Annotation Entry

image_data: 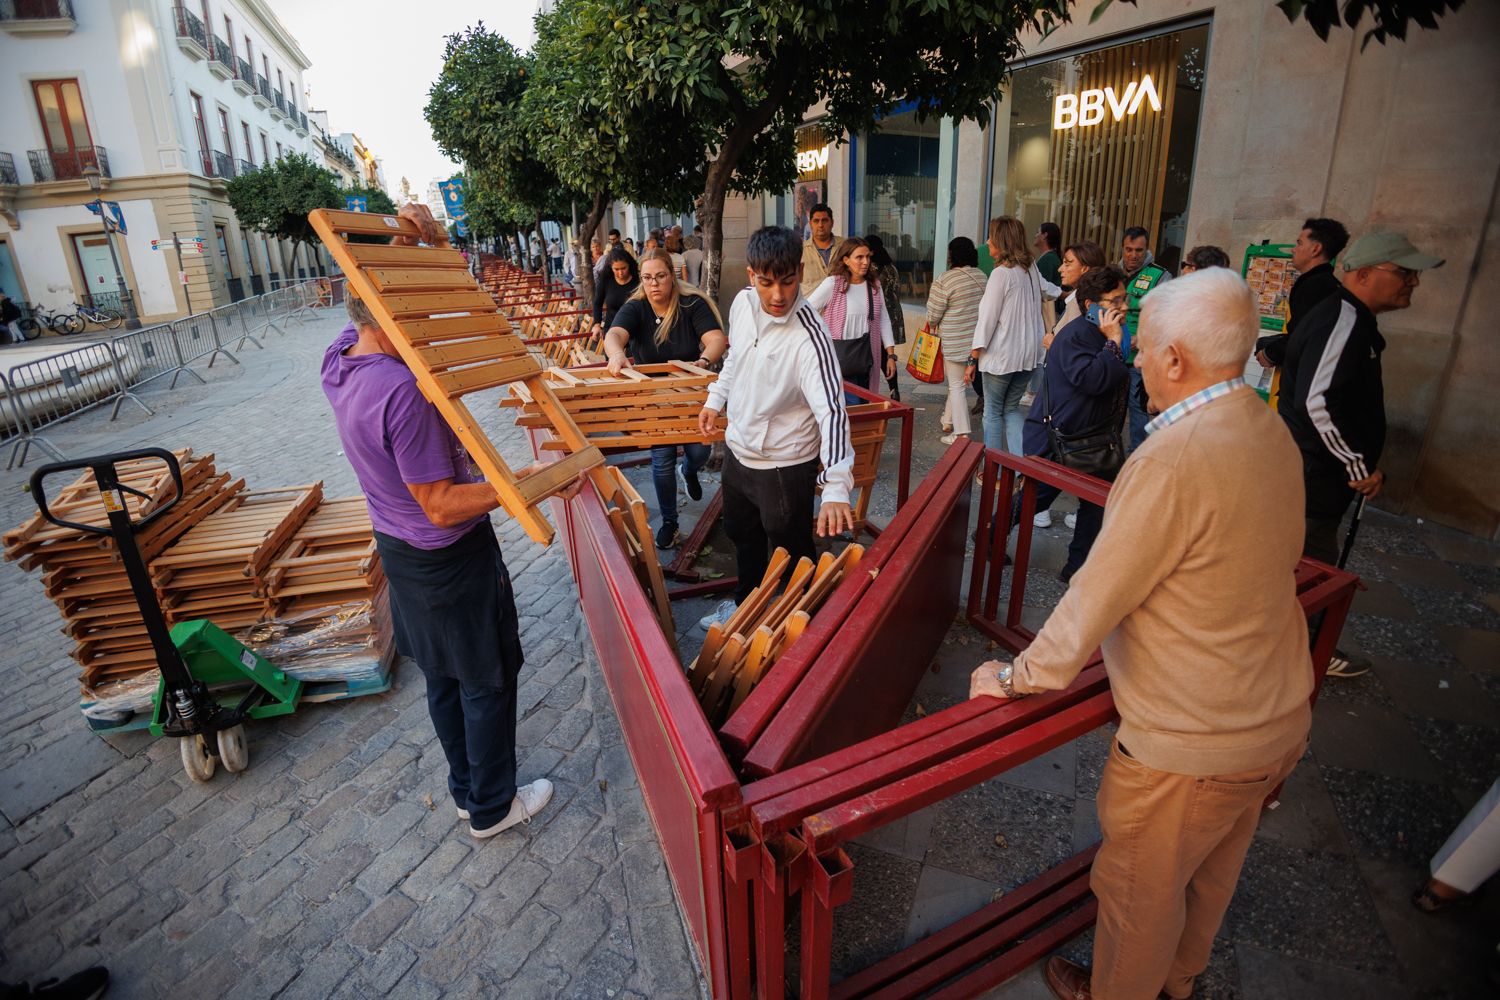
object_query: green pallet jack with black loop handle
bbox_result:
[32,448,303,781]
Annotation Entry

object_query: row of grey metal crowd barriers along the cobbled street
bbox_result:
[0,277,322,469]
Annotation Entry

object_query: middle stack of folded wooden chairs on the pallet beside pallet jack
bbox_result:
[152,483,323,633]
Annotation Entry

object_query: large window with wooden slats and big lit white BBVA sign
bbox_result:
[990,24,1209,270]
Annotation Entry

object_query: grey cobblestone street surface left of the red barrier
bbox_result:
[0,312,701,999]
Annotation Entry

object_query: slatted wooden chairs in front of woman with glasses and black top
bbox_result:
[501,361,726,448]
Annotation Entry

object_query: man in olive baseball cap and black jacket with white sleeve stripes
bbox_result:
[1280,232,1443,678]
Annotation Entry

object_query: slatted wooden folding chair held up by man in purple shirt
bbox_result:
[308,208,605,544]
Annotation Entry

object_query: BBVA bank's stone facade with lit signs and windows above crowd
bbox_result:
[741,0,1500,538]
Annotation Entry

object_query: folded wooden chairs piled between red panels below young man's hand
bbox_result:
[689,544,864,729]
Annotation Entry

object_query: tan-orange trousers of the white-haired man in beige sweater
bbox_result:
[1089,741,1307,1000]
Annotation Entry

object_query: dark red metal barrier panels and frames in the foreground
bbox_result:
[545,425,1358,1000]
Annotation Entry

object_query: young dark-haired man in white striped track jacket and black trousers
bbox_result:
[698,226,854,628]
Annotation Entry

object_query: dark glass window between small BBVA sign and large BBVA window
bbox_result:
[858,109,942,297]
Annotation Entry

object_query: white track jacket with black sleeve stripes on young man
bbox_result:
[708,288,854,504]
